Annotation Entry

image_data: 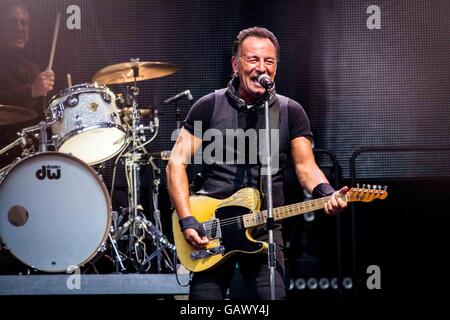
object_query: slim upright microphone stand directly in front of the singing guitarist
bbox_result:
[261,90,276,300]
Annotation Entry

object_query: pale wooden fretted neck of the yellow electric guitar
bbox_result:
[243,195,346,228]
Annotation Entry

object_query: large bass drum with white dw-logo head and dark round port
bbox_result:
[0,152,111,272]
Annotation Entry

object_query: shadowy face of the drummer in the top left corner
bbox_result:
[1,5,30,51]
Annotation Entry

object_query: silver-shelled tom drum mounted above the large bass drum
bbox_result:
[46,83,126,165]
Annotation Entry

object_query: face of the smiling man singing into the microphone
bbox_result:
[231,37,277,103]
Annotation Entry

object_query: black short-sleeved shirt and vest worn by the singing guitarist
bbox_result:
[184,89,312,208]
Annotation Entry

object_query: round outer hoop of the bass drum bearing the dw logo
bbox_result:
[0,151,112,273]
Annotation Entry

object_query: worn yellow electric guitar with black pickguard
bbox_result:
[172,185,388,272]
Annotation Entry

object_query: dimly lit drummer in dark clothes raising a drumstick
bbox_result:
[0,0,55,165]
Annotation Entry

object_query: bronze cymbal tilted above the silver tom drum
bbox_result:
[92,61,179,84]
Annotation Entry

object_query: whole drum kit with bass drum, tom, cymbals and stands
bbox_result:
[0,59,178,273]
